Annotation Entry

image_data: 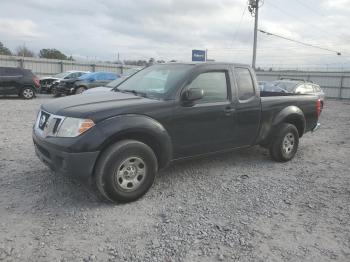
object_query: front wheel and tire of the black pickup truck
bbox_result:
[95,140,158,203]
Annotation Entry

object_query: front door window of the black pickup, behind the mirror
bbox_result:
[188,72,227,103]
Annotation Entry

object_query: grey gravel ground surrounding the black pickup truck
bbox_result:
[0,95,350,261]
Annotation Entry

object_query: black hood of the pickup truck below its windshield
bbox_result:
[41,92,161,123]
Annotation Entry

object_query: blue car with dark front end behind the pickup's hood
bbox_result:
[55,72,120,96]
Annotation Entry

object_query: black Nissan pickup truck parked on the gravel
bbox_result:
[33,63,321,202]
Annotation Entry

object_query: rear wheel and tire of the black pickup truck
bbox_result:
[269,123,299,162]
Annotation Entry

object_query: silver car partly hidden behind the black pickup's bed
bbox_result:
[262,79,325,108]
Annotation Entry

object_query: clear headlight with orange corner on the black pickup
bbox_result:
[57,117,95,137]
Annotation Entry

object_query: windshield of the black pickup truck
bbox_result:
[114,64,191,98]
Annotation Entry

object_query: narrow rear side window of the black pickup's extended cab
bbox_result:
[235,68,255,100]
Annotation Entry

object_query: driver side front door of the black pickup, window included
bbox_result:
[170,67,236,158]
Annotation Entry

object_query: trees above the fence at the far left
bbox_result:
[0,42,74,61]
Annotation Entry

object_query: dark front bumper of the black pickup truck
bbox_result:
[33,131,99,179]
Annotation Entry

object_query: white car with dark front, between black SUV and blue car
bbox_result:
[40,70,90,94]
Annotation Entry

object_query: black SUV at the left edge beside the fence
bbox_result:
[0,67,40,99]
